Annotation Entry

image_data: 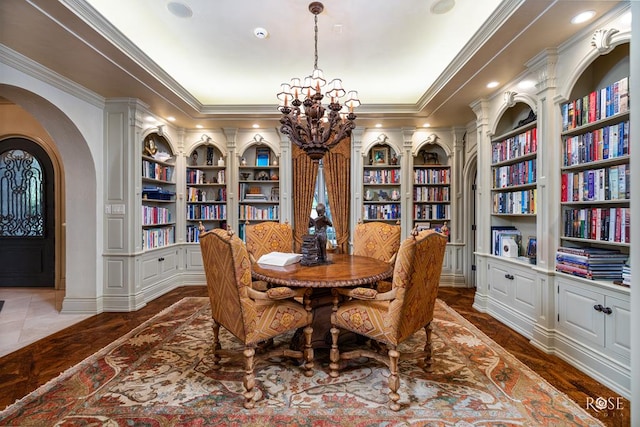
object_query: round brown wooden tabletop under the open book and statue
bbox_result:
[252,254,393,288]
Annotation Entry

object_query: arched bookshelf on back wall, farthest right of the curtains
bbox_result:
[413,145,451,229]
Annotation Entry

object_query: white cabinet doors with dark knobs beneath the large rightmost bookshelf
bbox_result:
[557,279,631,363]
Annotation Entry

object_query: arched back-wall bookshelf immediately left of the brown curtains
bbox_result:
[238,146,280,238]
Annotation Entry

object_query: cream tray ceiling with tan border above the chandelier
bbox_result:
[0,0,620,129]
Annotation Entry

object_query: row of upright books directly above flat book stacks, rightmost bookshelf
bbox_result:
[563,207,631,243]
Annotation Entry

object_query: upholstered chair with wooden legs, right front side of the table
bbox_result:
[329,229,447,411]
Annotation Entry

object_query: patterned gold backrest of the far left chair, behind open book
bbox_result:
[244,221,293,261]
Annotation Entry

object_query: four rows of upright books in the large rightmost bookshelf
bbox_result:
[560,76,631,264]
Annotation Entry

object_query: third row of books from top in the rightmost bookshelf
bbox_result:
[560,164,631,202]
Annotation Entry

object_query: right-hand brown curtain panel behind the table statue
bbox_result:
[323,138,351,253]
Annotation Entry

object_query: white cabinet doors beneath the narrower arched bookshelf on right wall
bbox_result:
[487,257,540,338]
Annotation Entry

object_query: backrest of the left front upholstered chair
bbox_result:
[199,229,254,342]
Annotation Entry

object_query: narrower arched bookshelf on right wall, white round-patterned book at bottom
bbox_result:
[491,102,539,262]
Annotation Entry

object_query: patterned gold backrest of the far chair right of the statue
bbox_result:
[353,221,401,262]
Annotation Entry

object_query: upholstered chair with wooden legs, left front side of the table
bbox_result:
[199,225,313,409]
